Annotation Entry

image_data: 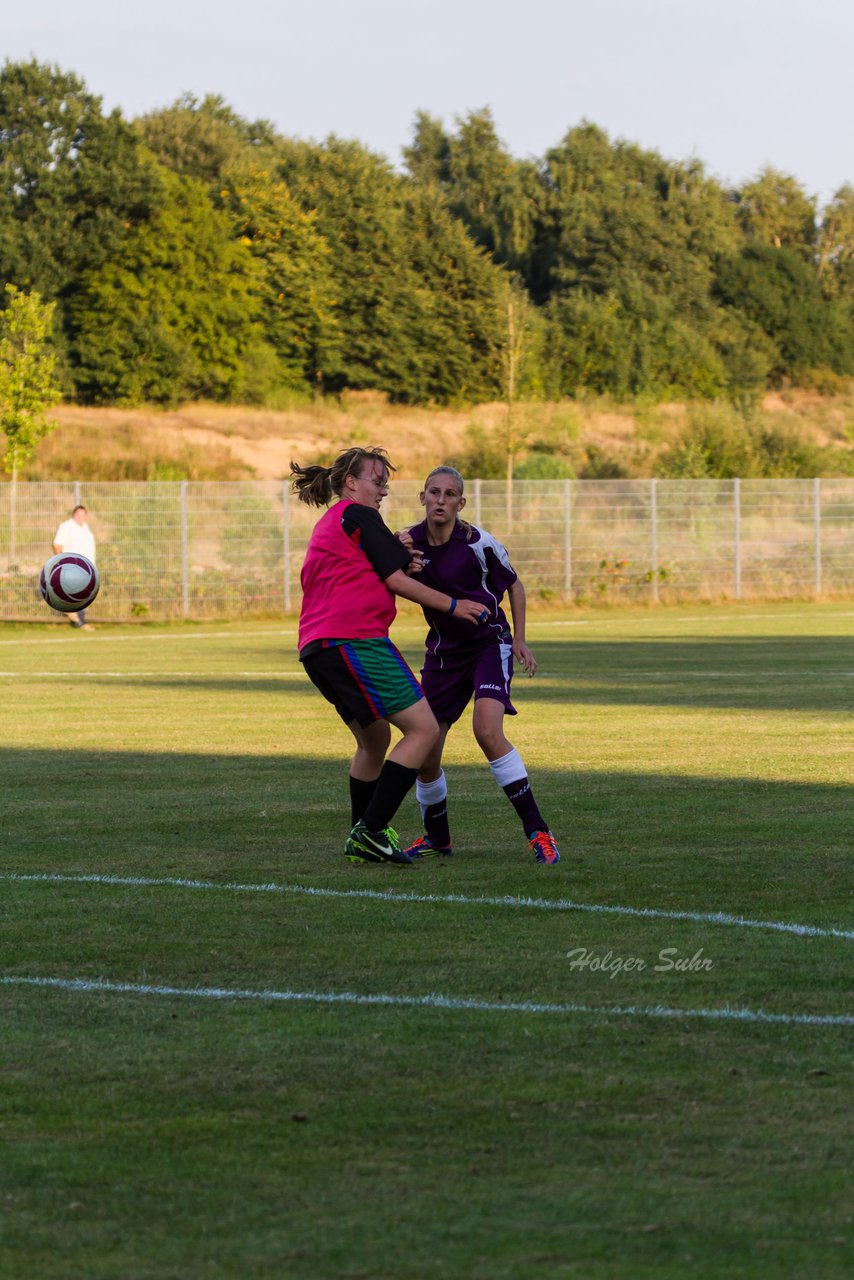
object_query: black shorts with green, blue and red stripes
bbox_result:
[300,637,424,728]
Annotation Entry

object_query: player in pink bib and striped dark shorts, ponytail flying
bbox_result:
[291,448,484,863]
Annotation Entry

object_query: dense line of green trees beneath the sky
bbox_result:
[0,60,854,404]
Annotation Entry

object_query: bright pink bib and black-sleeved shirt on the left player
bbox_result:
[298,499,410,657]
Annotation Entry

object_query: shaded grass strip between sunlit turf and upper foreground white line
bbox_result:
[0,750,854,924]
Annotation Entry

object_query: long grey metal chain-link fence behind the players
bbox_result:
[0,479,854,620]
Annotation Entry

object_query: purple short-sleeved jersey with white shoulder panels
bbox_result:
[410,521,516,654]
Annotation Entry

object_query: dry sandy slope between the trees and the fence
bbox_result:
[22,392,854,480]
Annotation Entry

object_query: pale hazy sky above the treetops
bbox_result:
[6,0,854,204]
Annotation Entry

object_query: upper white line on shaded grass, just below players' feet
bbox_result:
[0,872,854,941]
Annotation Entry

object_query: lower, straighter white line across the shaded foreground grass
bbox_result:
[0,975,854,1027]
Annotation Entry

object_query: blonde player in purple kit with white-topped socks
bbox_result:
[398,467,561,865]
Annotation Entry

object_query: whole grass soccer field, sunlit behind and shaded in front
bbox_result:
[0,603,854,1280]
